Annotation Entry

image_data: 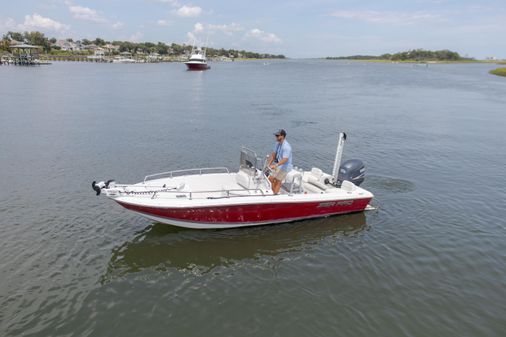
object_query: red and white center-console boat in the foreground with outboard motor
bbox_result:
[92,133,373,228]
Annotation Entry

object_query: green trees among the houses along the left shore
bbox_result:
[0,31,285,59]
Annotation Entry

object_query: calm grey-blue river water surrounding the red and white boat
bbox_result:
[0,60,506,337]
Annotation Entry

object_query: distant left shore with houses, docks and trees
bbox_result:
[0,31,285,64]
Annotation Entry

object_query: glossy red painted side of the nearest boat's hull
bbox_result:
[118,198,371,224]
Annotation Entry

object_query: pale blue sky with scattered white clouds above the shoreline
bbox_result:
[0,0,506,59]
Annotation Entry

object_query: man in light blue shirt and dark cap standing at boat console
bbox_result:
[268,129,293,194]
